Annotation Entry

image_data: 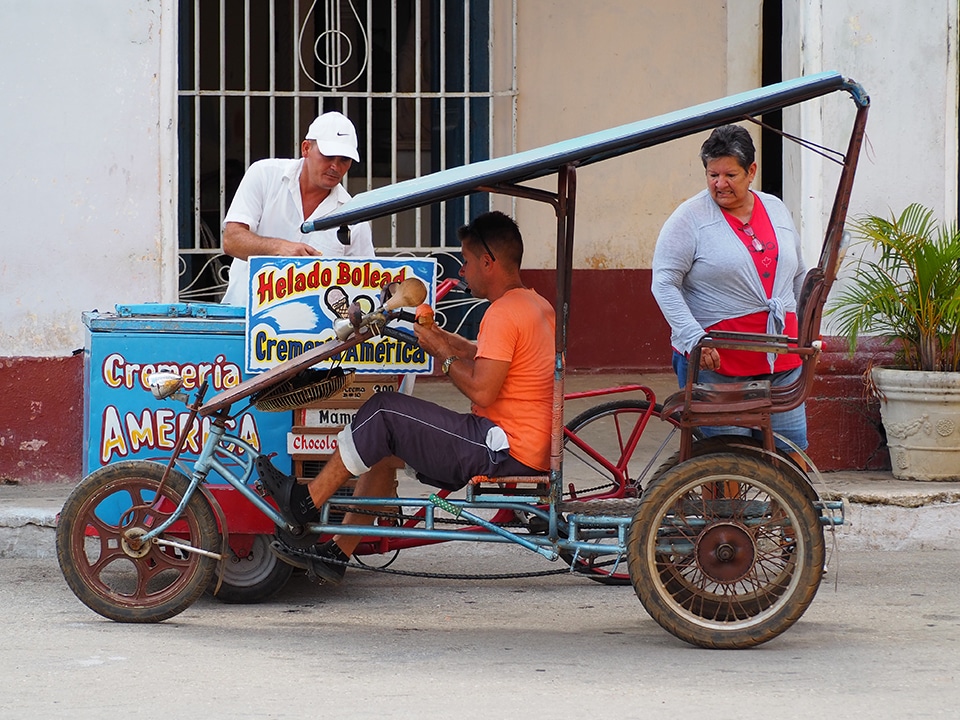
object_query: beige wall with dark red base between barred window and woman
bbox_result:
[506,0,761,371]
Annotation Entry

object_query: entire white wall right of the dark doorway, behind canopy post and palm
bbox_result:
[783,0,957,292]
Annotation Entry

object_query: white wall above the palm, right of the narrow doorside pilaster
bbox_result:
[823,0,957,218]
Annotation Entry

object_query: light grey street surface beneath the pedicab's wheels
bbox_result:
[7,543,960,720]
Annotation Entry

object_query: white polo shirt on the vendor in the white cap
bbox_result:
[222,158,374,305]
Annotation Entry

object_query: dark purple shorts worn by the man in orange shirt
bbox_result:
[339,392,543,490]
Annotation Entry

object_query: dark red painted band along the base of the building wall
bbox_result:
[0,270,890,483]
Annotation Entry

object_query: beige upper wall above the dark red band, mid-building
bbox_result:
[517,0,760,270]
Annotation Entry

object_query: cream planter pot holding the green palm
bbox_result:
[872,368,960,481]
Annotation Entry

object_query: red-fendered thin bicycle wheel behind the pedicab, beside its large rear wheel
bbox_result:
[560,400,679,585]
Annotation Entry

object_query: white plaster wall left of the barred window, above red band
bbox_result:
[0,0,176,357]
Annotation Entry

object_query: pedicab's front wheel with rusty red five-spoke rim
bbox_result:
[57,460,221,623]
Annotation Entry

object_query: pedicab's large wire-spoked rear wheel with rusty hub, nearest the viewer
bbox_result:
[627,453,824,649]
